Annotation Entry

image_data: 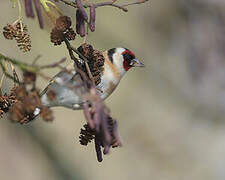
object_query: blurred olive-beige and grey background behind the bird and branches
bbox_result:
[0,0,225,180]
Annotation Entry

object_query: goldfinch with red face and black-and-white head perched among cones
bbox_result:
[35,47,144,114]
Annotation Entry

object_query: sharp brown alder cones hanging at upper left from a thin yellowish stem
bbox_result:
[3,21,31,52]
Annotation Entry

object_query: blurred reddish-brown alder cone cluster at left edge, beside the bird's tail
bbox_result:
[0,72,53,124]
